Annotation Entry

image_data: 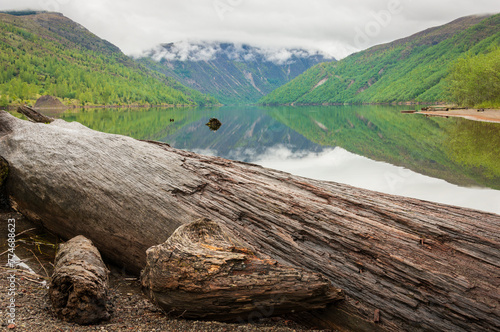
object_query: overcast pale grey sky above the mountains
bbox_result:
[0,0,500,58]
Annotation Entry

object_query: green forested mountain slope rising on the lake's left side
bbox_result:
[0,11,217,106]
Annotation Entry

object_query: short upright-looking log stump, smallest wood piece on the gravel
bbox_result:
[49,236,110,325]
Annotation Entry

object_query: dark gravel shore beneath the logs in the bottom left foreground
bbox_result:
[0,211,332,332]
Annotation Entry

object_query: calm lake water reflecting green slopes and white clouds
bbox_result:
[28,106,500,214]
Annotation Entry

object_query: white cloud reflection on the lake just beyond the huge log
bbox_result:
[196,145,500,214]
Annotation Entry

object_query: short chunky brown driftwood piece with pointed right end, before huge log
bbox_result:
[141,218,344,321]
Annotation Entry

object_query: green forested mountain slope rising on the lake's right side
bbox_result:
[260,15,500,104]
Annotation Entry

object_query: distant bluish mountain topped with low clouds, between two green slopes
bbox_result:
[137,42,332,104]
